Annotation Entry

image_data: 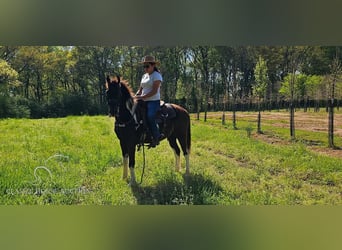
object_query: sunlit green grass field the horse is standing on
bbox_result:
[0,113,342,205]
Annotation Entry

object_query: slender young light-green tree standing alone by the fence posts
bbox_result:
[253,56,269,134]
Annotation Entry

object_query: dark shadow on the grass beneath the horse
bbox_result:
[132,174,223,205]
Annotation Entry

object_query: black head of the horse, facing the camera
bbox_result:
[106,76,121,116]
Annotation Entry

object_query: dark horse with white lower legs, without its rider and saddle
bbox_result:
[105,75,191,185]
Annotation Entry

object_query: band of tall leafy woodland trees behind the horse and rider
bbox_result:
[0,46,342,122]
